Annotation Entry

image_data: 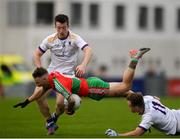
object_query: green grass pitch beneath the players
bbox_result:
[0,98,180,138]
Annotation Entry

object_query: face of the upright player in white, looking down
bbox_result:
[55,22,69,39]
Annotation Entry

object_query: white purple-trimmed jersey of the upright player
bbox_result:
[39,31,88,75]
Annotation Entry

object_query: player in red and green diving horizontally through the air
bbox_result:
[14,48,150,135]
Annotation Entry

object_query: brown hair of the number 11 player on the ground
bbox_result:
[126,93,144,107]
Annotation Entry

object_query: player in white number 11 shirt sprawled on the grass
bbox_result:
[105,93,180,137]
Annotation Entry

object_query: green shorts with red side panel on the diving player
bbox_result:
[86,77,109,100]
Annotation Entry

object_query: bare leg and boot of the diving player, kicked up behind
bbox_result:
[107,48,150,97]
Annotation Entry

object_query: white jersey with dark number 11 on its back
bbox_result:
[139,96,180,135]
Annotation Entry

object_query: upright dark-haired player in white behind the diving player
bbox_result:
[29,14,92,134]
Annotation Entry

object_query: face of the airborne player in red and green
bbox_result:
[34,74,50,88]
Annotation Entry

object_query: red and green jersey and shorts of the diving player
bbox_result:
[49,71,109,100]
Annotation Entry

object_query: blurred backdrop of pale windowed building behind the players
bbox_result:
[0,0,180,97]
